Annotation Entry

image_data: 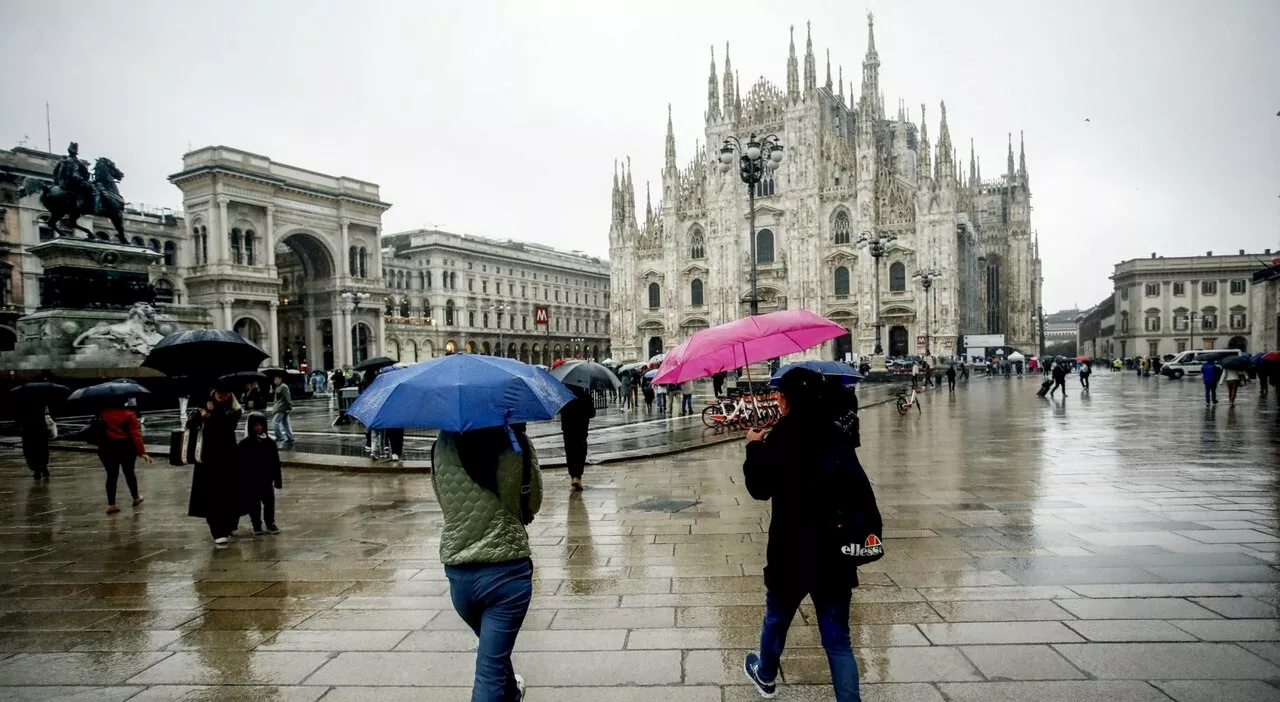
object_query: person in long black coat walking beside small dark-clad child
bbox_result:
[187,389,248,547]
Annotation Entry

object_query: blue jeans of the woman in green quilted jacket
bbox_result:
[444,559,534,702]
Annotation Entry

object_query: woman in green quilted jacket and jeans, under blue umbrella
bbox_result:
[431,425,543,702]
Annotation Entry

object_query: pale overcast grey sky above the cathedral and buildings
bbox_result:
[0,0,1280,309]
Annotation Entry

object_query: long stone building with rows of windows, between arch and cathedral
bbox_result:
[383,229,609,365]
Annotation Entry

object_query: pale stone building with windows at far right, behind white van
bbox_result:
[1111,250,1276,357]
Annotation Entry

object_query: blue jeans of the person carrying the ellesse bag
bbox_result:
[760,589,863,702]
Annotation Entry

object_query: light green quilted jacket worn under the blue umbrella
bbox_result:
[431,432,543,565]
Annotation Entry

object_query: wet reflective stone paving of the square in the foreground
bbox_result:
[0,374,1280,702]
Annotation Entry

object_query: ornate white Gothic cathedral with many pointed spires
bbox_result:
[609,18,1041,359]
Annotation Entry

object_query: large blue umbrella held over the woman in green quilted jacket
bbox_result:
[347,354,573,432]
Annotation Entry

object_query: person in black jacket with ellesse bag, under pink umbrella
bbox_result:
[742,369,881,702]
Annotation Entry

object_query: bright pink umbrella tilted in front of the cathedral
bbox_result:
[653,310,849,384]
